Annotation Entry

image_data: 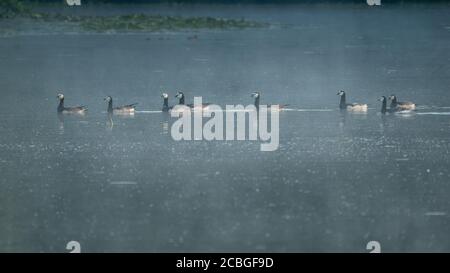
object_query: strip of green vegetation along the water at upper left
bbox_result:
[0,0,267,32]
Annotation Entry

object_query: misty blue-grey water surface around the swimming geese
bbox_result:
[0,5,450,252]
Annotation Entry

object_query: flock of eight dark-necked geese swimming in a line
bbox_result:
[57,91,416,115]
